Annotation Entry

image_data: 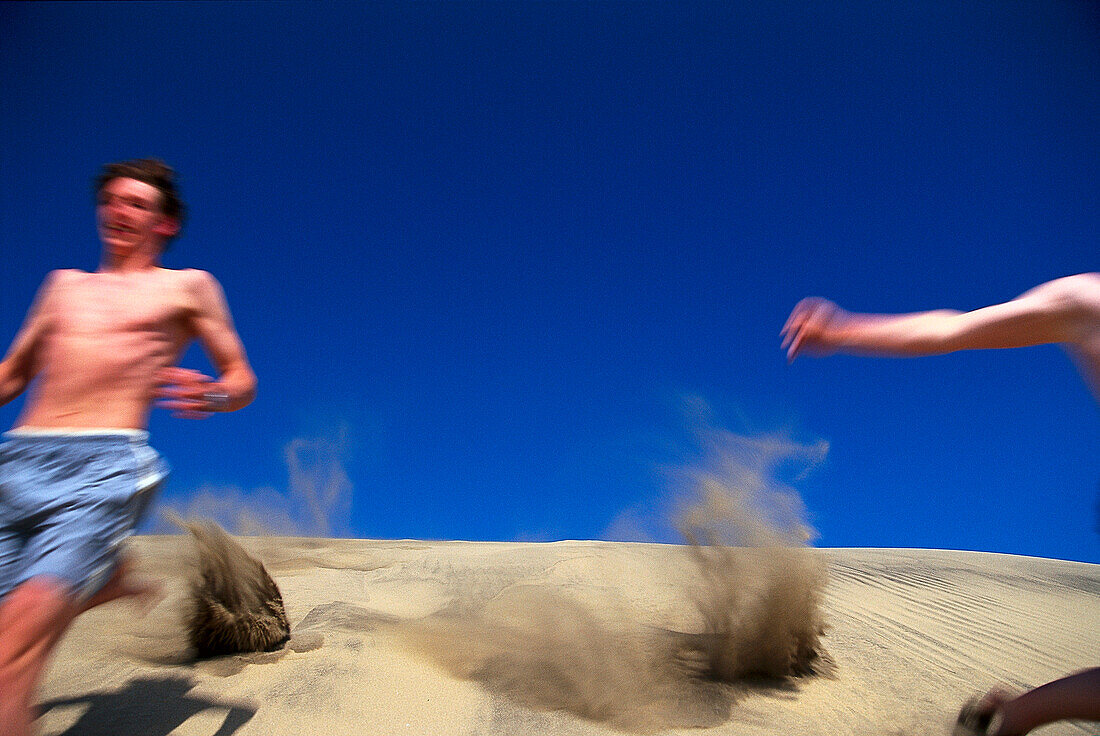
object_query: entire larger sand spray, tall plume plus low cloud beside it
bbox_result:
[403,418,826,733]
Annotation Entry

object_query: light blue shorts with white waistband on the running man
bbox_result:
[0,428,168,600]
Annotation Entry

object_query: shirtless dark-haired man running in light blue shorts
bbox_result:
[0,160,256,736]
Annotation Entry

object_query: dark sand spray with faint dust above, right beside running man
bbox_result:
[110,428,352,673]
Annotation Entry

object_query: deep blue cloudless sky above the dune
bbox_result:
[0,0,1100,562]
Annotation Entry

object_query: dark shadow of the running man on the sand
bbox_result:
[41,677,256,736]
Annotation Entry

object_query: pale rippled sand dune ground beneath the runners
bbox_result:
[39,536,1100,736]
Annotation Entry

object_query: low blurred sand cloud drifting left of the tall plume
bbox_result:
[398,586,724,732]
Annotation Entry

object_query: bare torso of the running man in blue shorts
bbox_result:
[17,267,205,428]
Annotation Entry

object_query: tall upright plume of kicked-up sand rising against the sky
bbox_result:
[678,430,827,682]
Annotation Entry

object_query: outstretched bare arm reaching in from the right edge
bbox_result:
[782,274,1100,361]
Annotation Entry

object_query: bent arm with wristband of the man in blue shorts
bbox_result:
[157,271,256,418]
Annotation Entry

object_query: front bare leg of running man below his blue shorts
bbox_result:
[0,578,80,736]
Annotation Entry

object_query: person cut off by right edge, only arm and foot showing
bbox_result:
[782,273,1100,736]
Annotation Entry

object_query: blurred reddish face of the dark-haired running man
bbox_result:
[96,177,177,255]
